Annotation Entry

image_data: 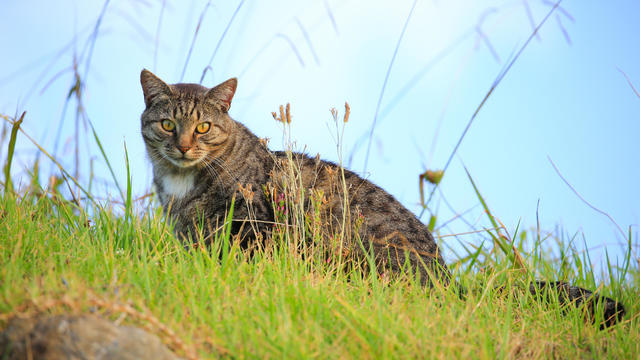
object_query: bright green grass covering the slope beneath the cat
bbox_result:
[0,176,640,359]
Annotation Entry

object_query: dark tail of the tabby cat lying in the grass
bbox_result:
[529,281,625,329]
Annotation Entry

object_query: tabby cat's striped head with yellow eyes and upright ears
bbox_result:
[140,69,238,172]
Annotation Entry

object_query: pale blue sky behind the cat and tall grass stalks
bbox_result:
[0,0,640,274]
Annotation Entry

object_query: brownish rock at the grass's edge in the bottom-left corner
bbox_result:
[0,315,178,360]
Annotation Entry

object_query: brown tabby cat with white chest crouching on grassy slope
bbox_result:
[140,69,625,326]
